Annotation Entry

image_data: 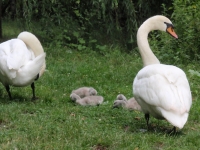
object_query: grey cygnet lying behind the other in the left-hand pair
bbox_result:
[72,87,97,98]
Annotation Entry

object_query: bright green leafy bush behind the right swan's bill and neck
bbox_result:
[150,0,200,64]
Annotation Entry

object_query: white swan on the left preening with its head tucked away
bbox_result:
[0,32,46,100]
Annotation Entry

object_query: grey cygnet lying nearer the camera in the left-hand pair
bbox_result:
[70,93,104,106]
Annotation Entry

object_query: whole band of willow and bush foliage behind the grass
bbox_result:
[0,0,200,63]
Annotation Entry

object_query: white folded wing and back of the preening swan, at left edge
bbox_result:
[0,39,34,79]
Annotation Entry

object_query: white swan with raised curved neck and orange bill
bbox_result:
[133,15,192,132]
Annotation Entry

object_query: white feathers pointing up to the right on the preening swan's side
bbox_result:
[18,53,46,82]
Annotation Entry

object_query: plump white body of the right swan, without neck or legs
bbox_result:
[133,64,192,128]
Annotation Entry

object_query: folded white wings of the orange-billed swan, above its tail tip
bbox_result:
[133,65,192,114]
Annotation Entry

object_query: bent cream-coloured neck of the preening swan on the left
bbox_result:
[17,31,44,57]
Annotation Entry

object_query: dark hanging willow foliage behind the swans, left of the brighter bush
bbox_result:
[3,0,171,53]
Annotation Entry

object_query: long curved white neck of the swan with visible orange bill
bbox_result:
[137,20,160,66]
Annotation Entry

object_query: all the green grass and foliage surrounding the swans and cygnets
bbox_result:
[0,0,200,150]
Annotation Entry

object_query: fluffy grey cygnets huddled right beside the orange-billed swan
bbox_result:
[113,94,141,111]
